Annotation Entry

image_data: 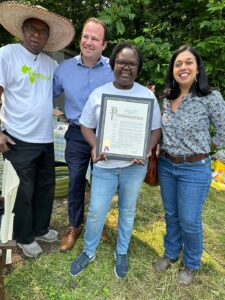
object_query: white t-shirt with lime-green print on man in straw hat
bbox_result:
[0,44,57,143]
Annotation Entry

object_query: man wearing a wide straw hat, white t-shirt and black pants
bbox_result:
[0,2,74,257]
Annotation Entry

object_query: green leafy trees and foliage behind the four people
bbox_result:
[0,0,225,95]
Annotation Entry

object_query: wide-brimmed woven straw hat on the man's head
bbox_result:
[0,1,75,51]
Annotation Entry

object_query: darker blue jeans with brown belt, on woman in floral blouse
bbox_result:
[158,156,212,270]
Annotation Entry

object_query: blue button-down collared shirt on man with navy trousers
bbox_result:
[53,55,114,124]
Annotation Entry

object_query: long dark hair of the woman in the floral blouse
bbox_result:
[163,45,212,100]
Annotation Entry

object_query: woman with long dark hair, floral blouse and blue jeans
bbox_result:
[153,45,225,285]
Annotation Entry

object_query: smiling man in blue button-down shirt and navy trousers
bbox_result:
[54,18,114,251]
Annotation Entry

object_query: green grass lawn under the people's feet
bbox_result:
[5,184,225,300]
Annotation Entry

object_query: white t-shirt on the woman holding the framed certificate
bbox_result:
[80,82,161,168]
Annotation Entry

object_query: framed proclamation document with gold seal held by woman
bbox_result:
[97,94,154,160]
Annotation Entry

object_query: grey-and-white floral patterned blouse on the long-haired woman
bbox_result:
[161,91,225,155]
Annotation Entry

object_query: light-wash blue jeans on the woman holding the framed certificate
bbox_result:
[84,165,147,257]
